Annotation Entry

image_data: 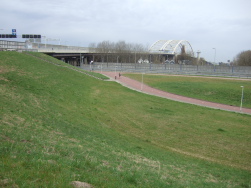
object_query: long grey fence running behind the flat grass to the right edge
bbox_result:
[81,62,251,78]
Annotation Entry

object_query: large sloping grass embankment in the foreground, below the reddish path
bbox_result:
[0,52,251,188]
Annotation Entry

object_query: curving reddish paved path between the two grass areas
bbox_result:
[102,72,251,115]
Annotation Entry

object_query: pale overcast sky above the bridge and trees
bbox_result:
[0,0,251,62]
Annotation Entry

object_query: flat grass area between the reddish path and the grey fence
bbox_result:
[124,74,251,108]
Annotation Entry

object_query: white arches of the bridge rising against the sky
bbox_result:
[149,40,194,56]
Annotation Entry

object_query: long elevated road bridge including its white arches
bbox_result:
[0,40,193,66]
